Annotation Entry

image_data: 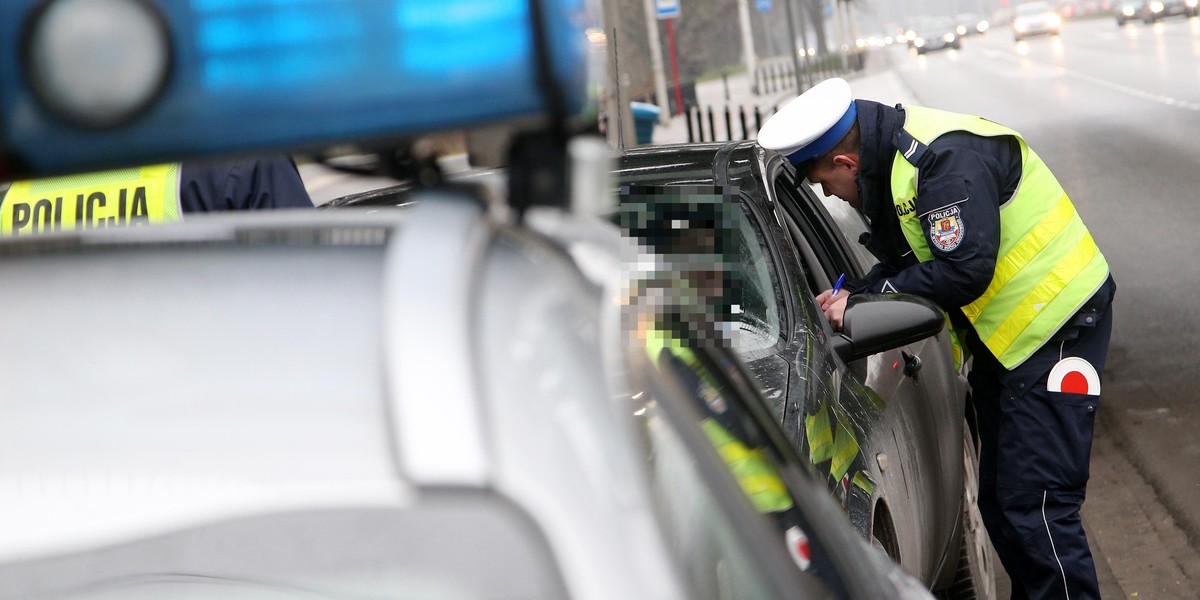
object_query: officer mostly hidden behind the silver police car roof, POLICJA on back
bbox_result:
[0,155,312,236]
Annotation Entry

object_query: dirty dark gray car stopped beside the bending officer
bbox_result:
[618,143,994,598]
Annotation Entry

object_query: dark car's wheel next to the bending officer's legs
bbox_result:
[946,424,996,600]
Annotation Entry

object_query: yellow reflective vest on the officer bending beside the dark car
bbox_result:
[892,107,1109,370]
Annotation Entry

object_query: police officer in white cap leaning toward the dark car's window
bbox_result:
[758,79,1116,600]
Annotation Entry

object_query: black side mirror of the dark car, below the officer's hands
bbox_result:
[832,294,946,362]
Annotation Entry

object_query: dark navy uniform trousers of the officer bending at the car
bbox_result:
[968,278,1115,600]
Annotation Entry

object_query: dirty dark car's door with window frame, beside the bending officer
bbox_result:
[762,150,964,583]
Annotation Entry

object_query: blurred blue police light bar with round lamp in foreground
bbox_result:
[0,0,589,181]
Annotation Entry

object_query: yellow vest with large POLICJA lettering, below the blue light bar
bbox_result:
[0,163,182,236]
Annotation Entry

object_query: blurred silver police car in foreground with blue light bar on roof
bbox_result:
[0,0,928,599]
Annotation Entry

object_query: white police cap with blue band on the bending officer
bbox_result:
[758,77,858,164]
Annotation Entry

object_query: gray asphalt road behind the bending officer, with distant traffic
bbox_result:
[888,18,1200,599]
